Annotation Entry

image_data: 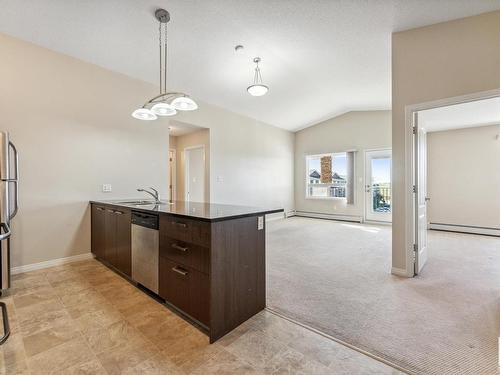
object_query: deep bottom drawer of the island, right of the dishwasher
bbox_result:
[160,257,210,326]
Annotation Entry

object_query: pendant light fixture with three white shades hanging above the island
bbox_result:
[132,9,198,121]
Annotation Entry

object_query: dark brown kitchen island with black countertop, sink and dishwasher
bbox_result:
[90,200,283,342]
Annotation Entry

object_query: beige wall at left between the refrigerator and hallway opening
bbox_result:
[0,34,168,266]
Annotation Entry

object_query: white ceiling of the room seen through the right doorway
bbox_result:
[418,97,500,132]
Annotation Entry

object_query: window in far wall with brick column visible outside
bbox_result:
[306,152,353,203]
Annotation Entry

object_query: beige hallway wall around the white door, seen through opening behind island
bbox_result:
[170,129,210,203]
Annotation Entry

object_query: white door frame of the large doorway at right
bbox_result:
[404,89,500,277]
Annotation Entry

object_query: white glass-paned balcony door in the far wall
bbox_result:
[365,149,392,222]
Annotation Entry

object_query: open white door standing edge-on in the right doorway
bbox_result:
[413,113,428,274]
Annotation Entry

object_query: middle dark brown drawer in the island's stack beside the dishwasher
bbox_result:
[160,236,210,273]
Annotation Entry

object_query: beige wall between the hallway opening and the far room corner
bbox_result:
[176,105,295,211]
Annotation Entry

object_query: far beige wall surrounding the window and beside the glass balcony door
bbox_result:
[295,111,391,217]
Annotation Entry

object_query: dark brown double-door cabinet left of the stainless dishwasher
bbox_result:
[91,205,132,276]
